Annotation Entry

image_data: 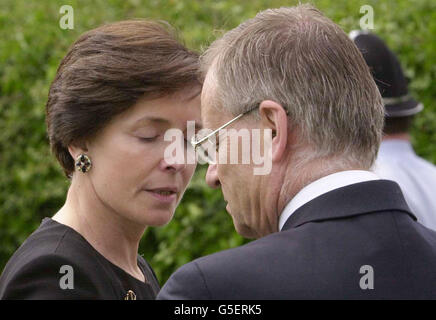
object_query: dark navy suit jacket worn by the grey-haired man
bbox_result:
[158,180,436,299]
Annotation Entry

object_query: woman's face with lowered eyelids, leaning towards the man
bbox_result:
[83,90,200,226]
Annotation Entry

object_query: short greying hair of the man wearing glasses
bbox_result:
[201,5,384,168]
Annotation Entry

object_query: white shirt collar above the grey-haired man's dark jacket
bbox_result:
[279,170,380,230]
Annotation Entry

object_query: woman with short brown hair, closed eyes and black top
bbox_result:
[0,20,201,299]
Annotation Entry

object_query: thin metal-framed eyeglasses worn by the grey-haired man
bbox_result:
[191,104,260,164]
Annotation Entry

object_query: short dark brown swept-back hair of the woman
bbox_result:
[46,20,201,177]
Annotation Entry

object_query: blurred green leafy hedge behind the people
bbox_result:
[0,0,436,284]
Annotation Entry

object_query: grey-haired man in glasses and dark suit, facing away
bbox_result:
[158,5,436,300]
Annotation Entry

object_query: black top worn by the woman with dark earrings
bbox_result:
[0,218,159,300]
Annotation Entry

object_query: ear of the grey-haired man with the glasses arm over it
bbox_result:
[259,100,288,162]
